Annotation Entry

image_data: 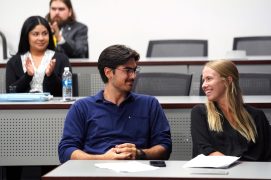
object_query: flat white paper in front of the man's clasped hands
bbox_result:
[95,161,159,172]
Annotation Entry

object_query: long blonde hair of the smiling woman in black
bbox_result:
[205,60,257,142]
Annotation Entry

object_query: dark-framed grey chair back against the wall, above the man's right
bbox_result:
[147,40,208,57]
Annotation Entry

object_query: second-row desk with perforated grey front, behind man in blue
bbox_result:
[0,96,271,166]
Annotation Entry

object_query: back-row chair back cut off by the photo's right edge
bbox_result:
[233,36,271,56]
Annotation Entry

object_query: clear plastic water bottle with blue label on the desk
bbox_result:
[62,67,72,101]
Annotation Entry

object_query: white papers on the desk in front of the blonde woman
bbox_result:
[183,154,240,168]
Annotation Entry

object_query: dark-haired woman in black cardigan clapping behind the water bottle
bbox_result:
[6,16,71,96]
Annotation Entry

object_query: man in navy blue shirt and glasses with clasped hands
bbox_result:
[58,45,172,163]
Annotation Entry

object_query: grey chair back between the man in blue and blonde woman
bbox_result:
[133,73,192,96]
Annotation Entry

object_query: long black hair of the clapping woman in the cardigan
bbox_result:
[18,16,55,54]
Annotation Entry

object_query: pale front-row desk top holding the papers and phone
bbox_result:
[42,160,271,180]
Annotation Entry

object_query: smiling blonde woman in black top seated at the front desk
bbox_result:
[191,60,271,161]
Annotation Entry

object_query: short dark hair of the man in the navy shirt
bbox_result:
[98,45,140,83]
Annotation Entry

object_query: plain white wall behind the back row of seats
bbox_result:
[0,0,271,60]
